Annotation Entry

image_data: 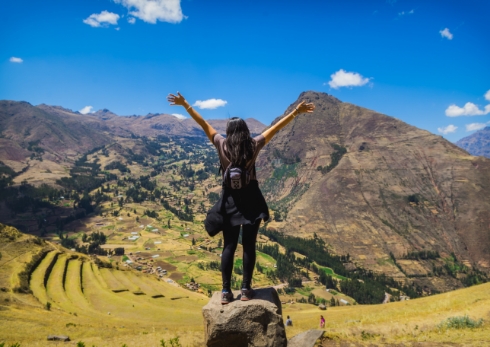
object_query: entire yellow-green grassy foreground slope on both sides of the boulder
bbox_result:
[0,225,490,347]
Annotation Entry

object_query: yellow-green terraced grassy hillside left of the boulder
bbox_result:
[0,224,207,347]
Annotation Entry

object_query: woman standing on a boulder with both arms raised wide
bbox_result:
[167,92,315,305]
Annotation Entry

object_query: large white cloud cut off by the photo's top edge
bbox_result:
[114,0,184,24]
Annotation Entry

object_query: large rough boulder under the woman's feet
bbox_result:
[202,288,287,347]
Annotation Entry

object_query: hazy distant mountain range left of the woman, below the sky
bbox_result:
[0,100,265,182]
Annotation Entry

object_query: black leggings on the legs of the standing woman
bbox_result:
[221,219,262,290]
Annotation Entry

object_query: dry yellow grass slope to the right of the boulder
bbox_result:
[283,283,490,346]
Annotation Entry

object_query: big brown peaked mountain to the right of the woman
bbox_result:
[259,92,490,290]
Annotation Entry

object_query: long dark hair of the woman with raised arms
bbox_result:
[225,117,255,166]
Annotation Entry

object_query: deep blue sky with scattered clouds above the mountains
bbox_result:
[0,0,490,141]
